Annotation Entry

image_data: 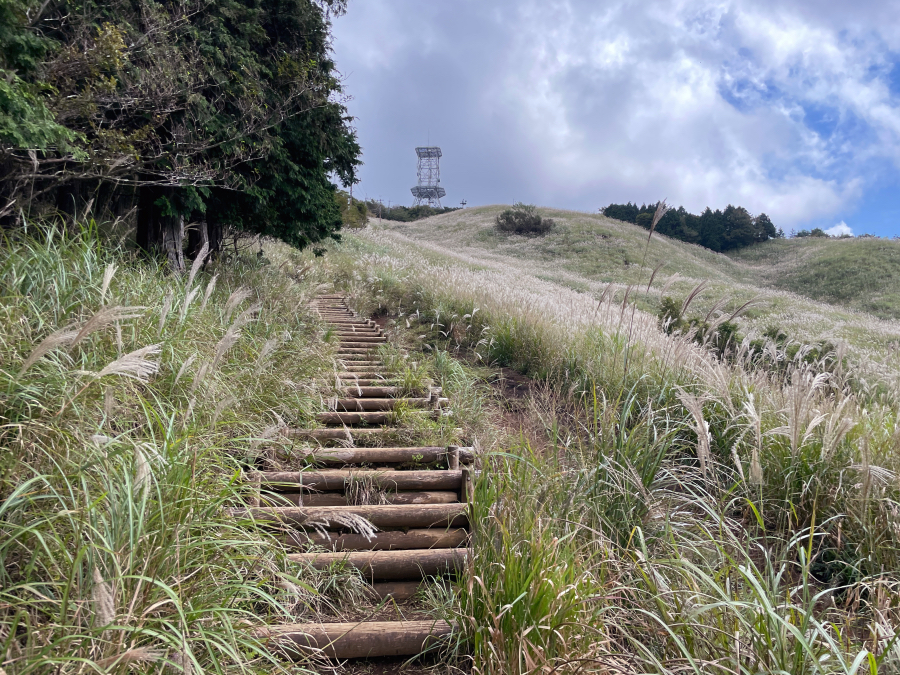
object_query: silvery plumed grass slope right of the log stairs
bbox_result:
[329,208,900,673]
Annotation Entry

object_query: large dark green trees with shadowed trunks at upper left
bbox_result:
[0,0,361,269]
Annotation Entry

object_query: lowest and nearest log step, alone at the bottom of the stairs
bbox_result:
[255,620,453,659]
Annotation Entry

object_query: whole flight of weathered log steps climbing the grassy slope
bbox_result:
[233,295,473,659]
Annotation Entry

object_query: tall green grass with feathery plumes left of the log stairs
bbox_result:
[0,223,338,673]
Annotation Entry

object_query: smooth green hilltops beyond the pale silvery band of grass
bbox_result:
[384,206,900,319]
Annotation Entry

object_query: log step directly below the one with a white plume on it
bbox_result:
[279,527,469,551]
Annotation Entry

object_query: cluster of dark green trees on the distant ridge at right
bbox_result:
[600,202,784,252]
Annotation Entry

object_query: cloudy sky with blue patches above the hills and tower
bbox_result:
[333,0,900,236]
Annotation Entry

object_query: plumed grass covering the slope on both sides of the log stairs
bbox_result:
[0,209,900,675]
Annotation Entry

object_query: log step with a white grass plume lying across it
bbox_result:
[228,504,469,530]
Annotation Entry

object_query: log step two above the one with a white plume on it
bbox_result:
[256,470,462,492]
